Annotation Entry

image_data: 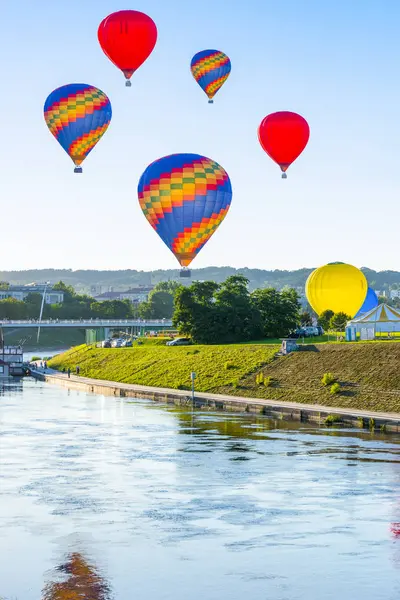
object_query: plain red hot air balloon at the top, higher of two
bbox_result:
[97,10,157,87]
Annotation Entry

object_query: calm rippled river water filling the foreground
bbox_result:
[0,379,400,600]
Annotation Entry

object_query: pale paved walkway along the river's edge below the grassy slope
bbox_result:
[28,367,400,426]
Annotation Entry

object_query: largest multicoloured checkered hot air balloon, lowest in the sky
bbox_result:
[138,154,232,277]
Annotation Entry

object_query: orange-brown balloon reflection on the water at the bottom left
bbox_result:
[43,552,111,600]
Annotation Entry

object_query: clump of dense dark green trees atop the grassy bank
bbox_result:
[173,275,300,344]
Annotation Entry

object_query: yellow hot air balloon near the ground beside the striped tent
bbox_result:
[306,263,368,317]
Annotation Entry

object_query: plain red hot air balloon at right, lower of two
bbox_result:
[258,111,310,179]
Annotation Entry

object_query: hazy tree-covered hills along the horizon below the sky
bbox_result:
[0,267,400,293]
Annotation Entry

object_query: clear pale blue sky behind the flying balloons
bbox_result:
[0,0,400,270]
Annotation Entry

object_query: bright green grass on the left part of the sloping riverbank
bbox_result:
[49,343,279,393]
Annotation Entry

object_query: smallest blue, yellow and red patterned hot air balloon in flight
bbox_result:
[190,50,231,104]
